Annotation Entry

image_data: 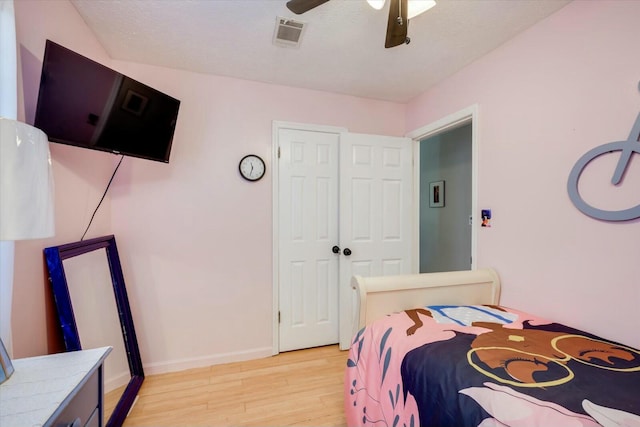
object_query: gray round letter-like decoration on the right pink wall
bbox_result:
[567,114,640,221]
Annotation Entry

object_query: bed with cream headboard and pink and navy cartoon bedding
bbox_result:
[344,269,640,427]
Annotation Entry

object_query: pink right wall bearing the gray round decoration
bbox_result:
[407,1,640,347]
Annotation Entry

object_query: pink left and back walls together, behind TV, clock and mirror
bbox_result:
[14,0,405,366]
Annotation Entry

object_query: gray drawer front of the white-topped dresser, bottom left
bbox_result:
[47,369,102,427]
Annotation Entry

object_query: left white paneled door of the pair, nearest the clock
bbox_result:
[278,129,340,351]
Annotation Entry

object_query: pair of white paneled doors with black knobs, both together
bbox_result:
[276,128,414,351]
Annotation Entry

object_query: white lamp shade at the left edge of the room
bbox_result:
[0,117,55,240]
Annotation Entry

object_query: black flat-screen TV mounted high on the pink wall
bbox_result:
[34,40,180,163]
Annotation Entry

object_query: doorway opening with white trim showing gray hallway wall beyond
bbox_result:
[407,105,479,272]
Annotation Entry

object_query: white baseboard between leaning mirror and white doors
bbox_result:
[143,347,273,375]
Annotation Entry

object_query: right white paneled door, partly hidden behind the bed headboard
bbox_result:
[340,133,414,350]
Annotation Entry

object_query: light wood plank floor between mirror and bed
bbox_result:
[117,345,347,427]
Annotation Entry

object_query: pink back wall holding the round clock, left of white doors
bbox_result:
[105,63,404,372]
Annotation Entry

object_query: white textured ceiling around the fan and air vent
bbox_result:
[71,0,568,102]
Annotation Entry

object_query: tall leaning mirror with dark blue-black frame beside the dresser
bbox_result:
[44,235,144,427]
